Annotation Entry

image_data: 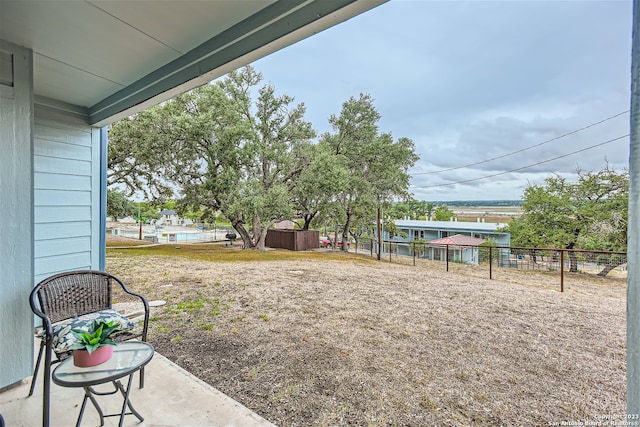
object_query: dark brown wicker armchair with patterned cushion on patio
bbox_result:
[29,270,149,426]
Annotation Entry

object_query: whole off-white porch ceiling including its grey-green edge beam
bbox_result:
[0,0,386,126]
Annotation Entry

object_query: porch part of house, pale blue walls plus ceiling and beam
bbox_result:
[0,0,384,398]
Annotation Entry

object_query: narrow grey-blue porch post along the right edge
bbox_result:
[627,0,640,415]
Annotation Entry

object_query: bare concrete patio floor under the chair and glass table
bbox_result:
[0,353,273,427]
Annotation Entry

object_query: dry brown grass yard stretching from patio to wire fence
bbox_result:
[107,250,626,426]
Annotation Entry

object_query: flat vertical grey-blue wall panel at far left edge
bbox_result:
[0,40,33,389]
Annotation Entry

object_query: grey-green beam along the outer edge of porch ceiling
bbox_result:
[89,0,387,126]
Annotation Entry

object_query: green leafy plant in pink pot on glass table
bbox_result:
[69,319,120,368]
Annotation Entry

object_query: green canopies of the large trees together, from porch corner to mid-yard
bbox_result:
[108,67,418,248]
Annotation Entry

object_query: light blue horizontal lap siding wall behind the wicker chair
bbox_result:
[34,108,100,282]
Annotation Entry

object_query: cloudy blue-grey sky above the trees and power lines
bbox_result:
[253,0,632,201]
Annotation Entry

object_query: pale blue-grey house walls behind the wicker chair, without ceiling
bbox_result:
[0,40,106,389]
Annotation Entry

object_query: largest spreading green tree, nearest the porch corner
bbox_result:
[109,67,315,248]
